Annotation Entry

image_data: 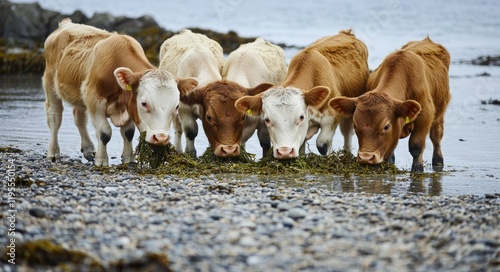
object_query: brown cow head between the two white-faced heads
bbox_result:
[181,80,273,158]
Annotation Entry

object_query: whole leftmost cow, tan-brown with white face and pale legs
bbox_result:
[42,19,198,166]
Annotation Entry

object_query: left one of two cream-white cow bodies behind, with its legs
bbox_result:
[159,29,224,157]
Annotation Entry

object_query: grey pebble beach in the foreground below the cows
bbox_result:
[0,152,500,271]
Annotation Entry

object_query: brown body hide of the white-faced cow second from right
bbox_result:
[281,30,369,112]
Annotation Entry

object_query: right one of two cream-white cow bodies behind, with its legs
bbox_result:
[222,38,286,156]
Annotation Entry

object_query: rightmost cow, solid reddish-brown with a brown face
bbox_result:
[328,37,451,172]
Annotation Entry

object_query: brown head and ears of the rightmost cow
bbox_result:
[328,92,421,164]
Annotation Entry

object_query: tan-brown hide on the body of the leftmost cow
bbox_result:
[44,21,155,126]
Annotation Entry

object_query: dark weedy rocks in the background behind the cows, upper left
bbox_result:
[0,0,287,75]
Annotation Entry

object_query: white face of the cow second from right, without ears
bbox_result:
[262,87,309,158]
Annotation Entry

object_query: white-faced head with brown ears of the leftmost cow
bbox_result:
[114,67,198,145]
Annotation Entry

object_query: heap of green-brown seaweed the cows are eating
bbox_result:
[136,135,406,177]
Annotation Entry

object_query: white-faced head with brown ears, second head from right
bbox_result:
[236,86,330,159]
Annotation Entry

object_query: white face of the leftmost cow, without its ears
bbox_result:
[136,70,180,145]
